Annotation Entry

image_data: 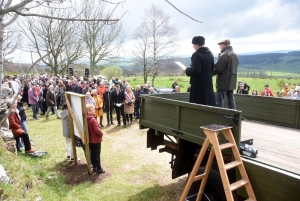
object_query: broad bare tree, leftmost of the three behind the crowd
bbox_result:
[23,8,84,74]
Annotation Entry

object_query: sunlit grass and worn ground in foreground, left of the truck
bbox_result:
[0,111,185,201]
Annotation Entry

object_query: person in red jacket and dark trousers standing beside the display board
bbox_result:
[86,104,105,174]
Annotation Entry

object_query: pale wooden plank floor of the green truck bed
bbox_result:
[241,120,300,174]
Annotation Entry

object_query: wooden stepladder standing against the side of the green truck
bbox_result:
[180,124,256,201]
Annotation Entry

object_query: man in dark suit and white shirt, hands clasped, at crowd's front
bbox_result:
[112,84,126,128]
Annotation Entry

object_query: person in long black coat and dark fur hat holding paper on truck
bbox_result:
[183,36,215,106]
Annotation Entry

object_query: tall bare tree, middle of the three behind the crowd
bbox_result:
[82,0,124,75]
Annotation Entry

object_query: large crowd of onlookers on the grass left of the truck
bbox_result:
[4,75,166,168]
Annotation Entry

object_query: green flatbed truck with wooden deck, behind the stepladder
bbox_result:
[140,93,300,201]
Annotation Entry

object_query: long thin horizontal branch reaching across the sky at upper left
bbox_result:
[12,10,120,22]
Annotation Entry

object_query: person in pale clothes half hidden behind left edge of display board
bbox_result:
[60,103,74,161]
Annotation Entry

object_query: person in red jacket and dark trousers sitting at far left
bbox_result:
[7,102,35,153]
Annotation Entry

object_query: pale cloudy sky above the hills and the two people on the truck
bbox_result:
[114,0,300,55]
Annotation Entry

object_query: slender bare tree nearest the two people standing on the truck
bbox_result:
[131,5,177,86]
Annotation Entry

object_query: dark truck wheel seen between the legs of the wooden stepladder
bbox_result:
[187,164,226,201]
